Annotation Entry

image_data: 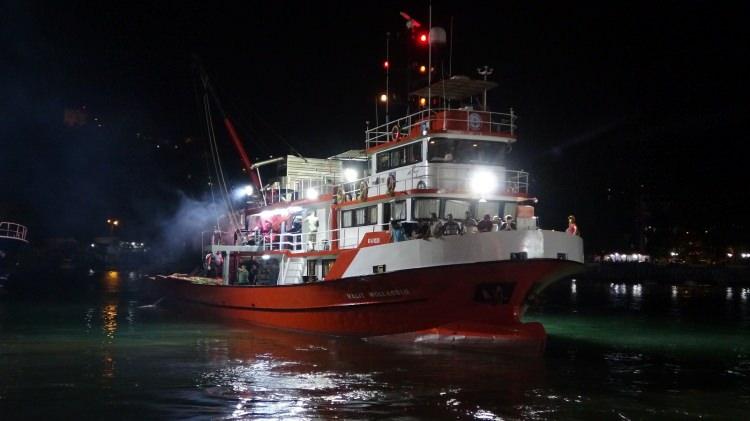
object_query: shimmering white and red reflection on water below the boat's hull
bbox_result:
[191,325,544,419]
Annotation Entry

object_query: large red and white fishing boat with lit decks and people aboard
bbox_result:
[154,20,583,350]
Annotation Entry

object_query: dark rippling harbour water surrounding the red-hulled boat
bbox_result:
[0,272,750,420]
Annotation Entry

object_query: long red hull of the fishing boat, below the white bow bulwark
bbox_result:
[156,260,581,338]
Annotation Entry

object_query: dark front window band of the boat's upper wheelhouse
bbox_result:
[427,138,505,165]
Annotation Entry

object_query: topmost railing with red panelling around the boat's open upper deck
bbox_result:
[365,108,517,149]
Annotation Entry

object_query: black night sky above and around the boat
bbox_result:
[0,1,750,253]
